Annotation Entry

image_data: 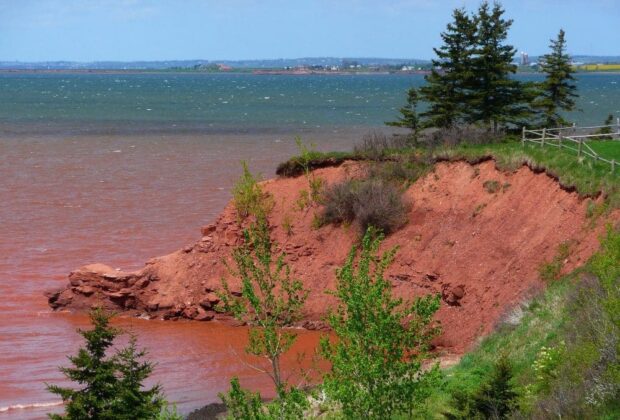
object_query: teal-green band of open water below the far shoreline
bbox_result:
[0,73,620,133]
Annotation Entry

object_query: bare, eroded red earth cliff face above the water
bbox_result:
[48,161,619,353]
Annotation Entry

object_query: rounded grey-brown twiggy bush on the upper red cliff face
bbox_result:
[321,178,409,235]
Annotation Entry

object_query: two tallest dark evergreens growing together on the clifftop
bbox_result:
[420,1,536,133]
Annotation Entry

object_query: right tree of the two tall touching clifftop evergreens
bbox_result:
[467,1,529,132]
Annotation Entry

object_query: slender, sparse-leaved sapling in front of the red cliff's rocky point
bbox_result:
[219,218,308,413]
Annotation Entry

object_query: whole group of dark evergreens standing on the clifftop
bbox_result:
[387,1,577,134]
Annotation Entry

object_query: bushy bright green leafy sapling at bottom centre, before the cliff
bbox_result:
[321,228,440,418]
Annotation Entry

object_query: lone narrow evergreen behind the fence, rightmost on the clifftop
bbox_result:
[537,30,578,127]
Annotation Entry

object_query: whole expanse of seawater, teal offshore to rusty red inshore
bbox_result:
[0,73,620,419]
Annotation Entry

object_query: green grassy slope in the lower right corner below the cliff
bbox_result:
[424,226,620,418]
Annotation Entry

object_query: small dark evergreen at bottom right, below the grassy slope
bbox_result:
[446,354,517,419]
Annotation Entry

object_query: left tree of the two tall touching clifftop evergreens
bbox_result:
[420,9,476,128]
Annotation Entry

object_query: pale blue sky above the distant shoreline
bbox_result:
[0,0,620,61]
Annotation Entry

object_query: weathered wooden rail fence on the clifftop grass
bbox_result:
[521,118,620,172]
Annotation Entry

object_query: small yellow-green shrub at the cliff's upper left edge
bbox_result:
[232,162,273,221]
